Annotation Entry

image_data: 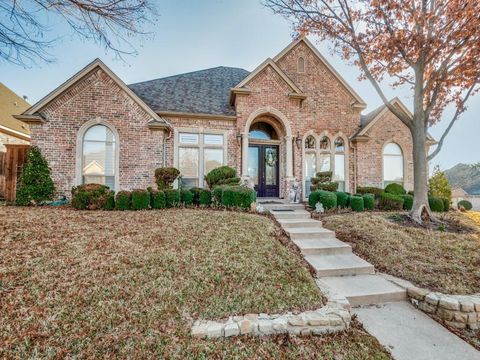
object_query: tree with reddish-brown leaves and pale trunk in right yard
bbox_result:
[263,0,480,222]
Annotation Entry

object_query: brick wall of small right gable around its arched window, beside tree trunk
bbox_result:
[357,111,413,190]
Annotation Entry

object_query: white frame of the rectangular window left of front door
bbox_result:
[173,128,228,189]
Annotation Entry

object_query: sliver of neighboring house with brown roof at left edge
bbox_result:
[0,82,30,152]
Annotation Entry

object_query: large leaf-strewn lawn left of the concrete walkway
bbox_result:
[0,206,390,359]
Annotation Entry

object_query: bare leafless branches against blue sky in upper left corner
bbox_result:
[0,0,155,66]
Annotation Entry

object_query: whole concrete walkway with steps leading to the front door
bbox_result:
[262,200,480,360]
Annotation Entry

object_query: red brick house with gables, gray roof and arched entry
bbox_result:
[15,38,433,197]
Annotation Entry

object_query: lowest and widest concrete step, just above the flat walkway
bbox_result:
[322,275,407,306]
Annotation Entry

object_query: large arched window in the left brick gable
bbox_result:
[82,124,116,190]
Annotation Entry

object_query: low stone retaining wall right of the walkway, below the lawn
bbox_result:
[407,286,480,330]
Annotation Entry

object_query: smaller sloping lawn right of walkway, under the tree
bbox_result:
[322,212,480,294]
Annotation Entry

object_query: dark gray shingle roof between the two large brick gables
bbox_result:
[128,66,249,115]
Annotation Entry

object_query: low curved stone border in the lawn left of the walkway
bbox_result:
[191,279,352,338]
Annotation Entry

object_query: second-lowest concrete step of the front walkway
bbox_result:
[305,254,375,277]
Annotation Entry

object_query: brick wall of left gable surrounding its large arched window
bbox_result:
[31,68,163,195]
